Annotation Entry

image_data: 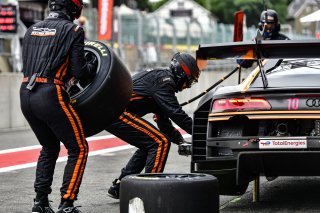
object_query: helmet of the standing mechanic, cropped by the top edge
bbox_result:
[49,0,83,19]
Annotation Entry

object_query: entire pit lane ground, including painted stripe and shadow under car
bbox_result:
[0,130,320,213]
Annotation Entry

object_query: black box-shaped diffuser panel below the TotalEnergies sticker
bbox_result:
[237,151,320,183]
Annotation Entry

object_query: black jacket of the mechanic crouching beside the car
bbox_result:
[127,69,192,139]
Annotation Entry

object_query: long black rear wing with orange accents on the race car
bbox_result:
[196,40,320,69]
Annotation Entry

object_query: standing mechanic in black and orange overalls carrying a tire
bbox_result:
[20,0,97,213]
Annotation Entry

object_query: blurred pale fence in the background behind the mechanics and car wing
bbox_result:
[85,7,312,73]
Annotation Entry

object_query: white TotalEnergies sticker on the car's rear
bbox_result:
[259,138,307,149]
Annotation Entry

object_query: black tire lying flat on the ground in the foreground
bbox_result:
[120,173,219,213]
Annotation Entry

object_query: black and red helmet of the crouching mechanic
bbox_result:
[170,52,200,91]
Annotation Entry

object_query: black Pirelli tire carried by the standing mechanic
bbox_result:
[68,41,132,137]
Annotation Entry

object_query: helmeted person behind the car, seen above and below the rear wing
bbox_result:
[237,9,290,68]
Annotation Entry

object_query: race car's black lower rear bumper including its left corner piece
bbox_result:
[191,150,320,184]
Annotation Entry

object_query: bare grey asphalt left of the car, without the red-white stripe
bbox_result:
[0,128,198,213]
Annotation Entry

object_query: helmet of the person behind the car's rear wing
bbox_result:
[259,9,280,38]
